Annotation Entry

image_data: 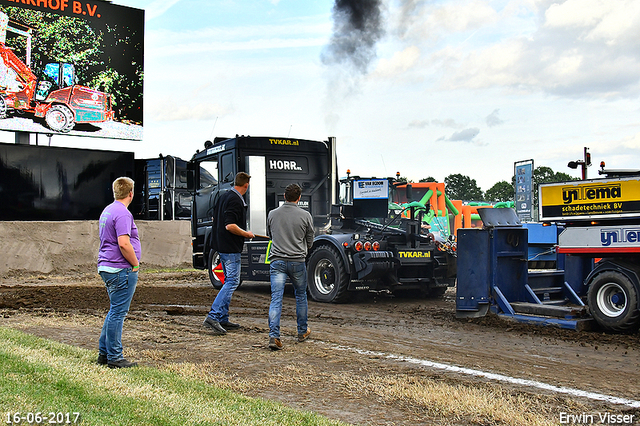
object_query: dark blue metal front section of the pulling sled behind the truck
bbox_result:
[456,209,591,330]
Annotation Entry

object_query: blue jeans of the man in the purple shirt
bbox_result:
[98,268,138,362]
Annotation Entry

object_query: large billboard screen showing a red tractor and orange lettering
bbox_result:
[0,0,144,140]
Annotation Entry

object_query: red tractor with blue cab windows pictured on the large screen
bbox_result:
[0,42,113,133]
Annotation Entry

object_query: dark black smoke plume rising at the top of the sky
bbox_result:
[321,0,384,74]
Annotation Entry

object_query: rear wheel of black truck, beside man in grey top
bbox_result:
[307,245,349,303]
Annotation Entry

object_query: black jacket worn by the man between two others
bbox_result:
[212,190,247,253]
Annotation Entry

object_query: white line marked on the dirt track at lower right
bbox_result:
[334,345,640,408]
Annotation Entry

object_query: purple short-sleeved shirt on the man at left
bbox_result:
[98,201,140,268]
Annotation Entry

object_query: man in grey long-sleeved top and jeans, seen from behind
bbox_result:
[267,183,313,351]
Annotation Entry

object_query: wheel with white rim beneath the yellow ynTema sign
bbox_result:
[587,271,640,332]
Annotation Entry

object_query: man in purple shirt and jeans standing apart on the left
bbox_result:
[98,177,140,368]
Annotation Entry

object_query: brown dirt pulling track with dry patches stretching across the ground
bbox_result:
[0,271,640,425]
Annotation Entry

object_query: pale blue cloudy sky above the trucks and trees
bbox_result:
[0,0,640,191]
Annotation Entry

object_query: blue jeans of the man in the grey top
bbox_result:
[269,260,308,337]
